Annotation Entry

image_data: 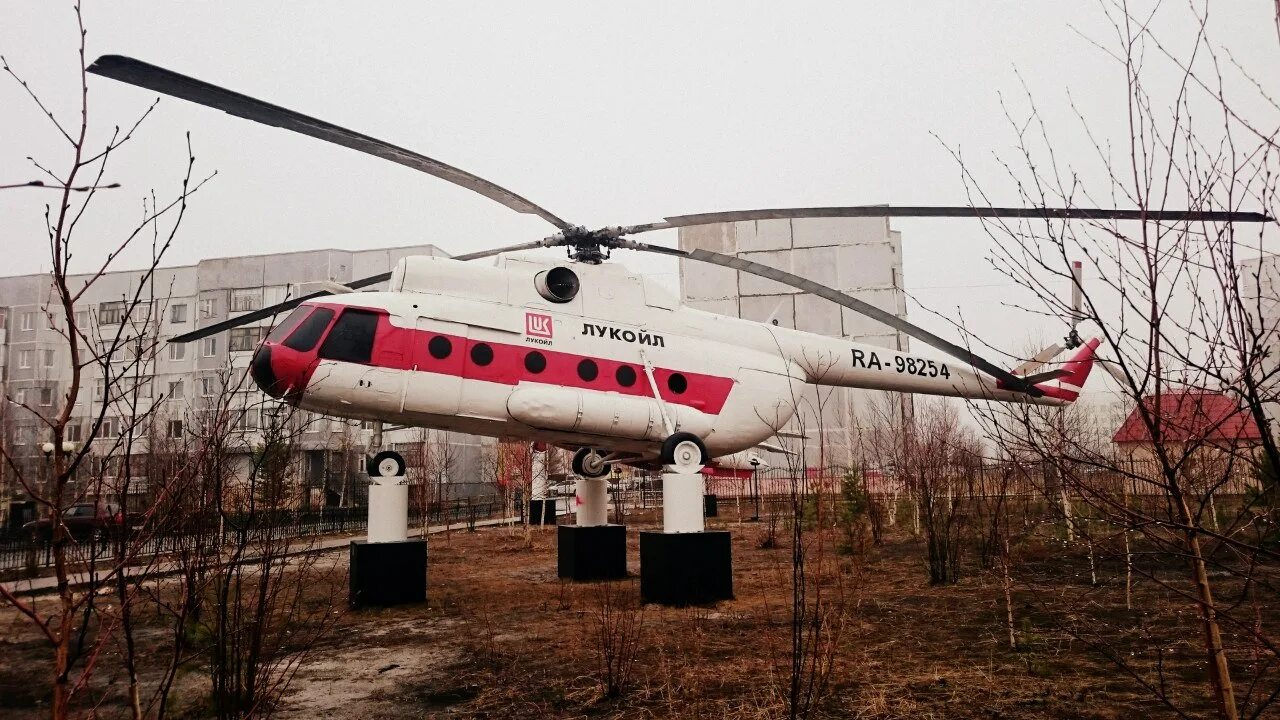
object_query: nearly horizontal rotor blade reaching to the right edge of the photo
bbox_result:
[622,205,1271,234]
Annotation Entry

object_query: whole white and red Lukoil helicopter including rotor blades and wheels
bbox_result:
[90,55,1266,478]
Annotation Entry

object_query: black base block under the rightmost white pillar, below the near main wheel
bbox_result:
[640,530,733,606]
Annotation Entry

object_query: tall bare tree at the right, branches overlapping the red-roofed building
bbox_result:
[956,3,1280,719]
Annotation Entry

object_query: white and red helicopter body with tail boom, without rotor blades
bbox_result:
[252,256,1083,460]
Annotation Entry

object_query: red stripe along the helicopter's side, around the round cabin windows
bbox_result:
[291,304,733,415]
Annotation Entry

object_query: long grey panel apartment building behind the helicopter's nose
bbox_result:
[0,245,493,507]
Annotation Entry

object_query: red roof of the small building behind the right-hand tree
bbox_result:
[1111,389,1262,448]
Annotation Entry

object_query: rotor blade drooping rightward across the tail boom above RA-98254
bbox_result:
[670,244,1044,397]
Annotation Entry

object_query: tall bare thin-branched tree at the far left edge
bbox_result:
[0,4,207,717]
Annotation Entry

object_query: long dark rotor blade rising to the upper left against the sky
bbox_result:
[88,55,571,229]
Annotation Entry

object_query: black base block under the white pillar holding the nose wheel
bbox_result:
[349,539,426,610]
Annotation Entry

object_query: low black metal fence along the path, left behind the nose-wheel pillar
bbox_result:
[0,496,509,570]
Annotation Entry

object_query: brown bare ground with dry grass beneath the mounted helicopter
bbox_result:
[0,504,1280,720]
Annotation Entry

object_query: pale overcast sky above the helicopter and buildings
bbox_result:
[0,0,1280,404]
